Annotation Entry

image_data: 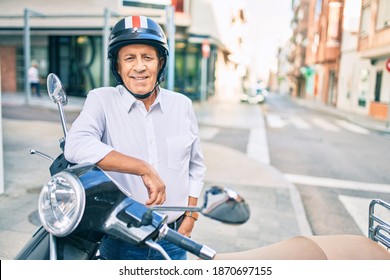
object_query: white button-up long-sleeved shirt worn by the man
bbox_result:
[65,86,206,222]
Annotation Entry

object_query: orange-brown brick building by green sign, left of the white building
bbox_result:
[305,0,343,106]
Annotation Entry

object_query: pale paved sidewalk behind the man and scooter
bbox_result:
[0,91,311,259]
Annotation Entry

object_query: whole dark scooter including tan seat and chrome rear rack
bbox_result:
[16,74,390,260]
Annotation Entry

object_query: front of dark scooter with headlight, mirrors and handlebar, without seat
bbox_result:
[16,73,250,260]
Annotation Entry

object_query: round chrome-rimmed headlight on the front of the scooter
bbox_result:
[38,171,85,237]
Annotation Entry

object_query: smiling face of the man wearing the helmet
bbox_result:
[117,44,163,94]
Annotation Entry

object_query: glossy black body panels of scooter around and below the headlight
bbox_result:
[15,165,164,260]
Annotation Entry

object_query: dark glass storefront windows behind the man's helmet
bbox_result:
[0,25,217,100]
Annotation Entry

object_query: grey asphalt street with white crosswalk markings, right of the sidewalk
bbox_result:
[263,94,390,235]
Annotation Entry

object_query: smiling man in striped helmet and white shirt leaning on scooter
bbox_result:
[65,16,206,259]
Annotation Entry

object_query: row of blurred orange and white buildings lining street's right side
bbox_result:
[290,0,390,120]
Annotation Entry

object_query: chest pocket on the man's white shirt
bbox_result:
[167,136,192,170]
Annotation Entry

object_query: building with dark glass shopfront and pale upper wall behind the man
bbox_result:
[0,0,239,100]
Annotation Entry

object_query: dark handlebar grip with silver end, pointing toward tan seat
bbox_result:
[162,225,216,260]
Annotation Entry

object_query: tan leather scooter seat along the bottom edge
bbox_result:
[214,235,390,260]
